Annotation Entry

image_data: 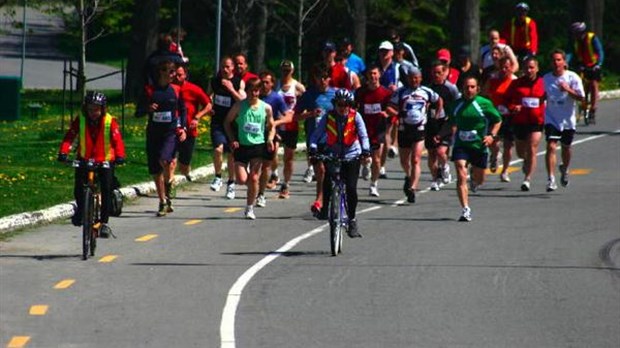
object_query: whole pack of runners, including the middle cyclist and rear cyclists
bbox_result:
[61,3,603,237]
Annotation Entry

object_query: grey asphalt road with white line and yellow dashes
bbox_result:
[0,101,620,348]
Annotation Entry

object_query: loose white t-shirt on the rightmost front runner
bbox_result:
[543,70,585,131]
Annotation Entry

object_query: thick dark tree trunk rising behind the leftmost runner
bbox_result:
[125,0,162,100]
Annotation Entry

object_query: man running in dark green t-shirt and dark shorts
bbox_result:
[446,76,502,221]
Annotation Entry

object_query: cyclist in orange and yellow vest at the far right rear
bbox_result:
[566,22,605,124]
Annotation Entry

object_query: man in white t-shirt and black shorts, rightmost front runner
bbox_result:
[543,49,585,192]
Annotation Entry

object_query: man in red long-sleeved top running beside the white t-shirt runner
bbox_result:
[506,57,545,191]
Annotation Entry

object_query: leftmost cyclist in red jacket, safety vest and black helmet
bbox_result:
[58,91,125,238]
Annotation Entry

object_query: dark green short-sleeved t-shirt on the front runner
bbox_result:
[446,95,502,151]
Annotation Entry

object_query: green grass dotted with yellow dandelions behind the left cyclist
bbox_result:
[0,91,212,217]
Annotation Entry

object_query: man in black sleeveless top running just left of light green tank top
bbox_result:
[210,56,246,199]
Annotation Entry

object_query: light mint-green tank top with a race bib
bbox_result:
[235,99,267,146]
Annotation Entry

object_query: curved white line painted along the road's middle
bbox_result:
[220,129,620,348]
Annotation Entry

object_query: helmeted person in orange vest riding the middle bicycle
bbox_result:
[309,89,370,238]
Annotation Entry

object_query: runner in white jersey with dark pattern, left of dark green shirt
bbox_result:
[387,68,443,203]
